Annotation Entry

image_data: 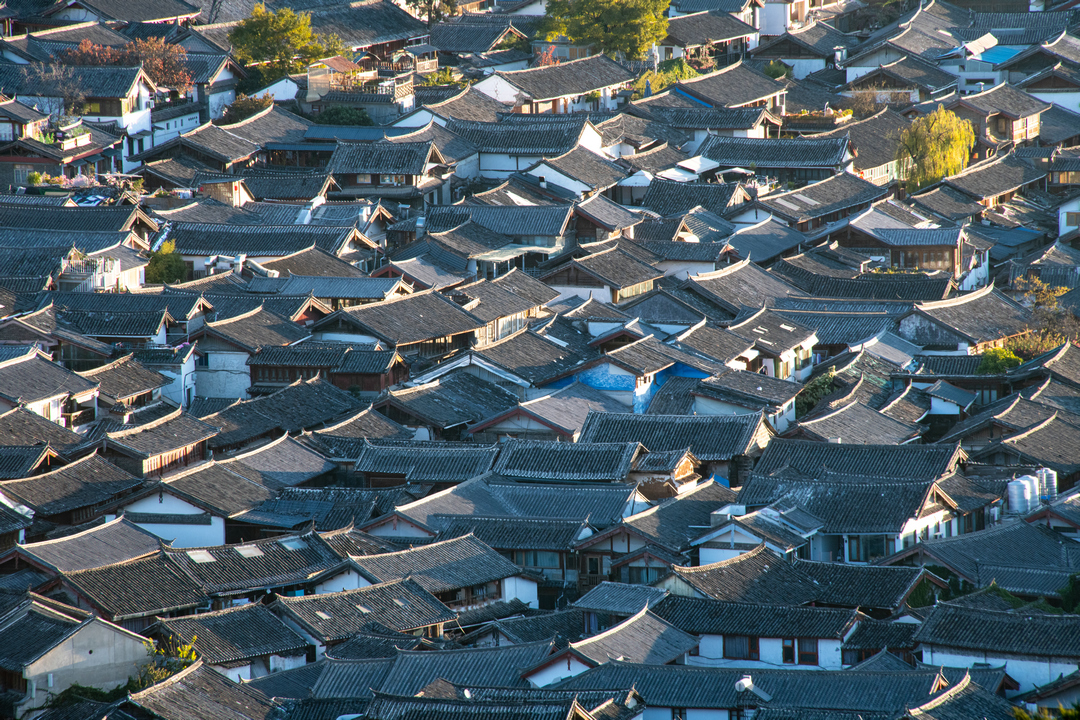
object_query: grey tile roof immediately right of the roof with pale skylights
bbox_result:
[353,535,522,593]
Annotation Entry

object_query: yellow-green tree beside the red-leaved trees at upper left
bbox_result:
[229,3,347,82]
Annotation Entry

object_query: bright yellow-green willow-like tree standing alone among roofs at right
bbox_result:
[896,106,975,192]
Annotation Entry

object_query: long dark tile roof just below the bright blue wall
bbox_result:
[579,412,762,462]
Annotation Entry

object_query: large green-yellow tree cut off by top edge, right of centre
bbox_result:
[541,0,669,59]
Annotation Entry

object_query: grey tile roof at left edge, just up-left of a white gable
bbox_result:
[0,453,143,516]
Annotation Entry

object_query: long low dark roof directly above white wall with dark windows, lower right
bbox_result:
[652,595,863,640]
